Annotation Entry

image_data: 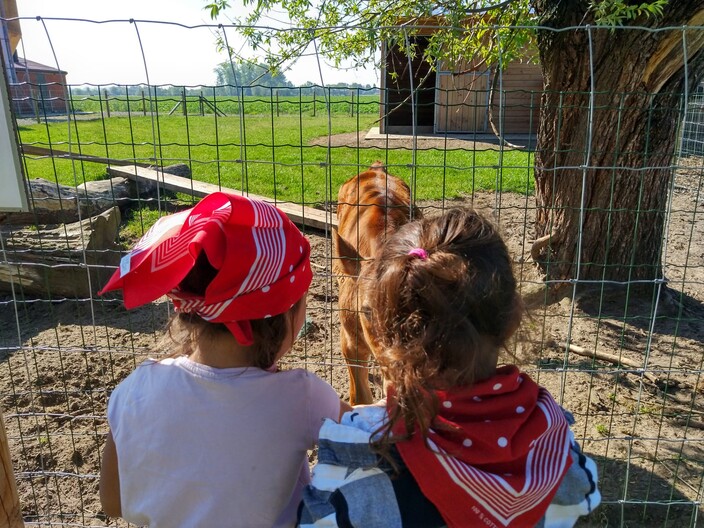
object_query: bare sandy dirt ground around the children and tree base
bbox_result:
[0,151,704,528]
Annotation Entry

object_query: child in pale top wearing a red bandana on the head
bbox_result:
[100,193,349,528]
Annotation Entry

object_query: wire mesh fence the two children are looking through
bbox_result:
[0,13,704,527]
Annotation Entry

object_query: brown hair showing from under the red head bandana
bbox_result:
[160,252,305,369]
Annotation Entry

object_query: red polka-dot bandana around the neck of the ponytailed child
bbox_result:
[388,366,571,527]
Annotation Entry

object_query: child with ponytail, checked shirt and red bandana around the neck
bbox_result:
[299,209,600,528]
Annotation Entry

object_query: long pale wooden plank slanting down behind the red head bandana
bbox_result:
[108,165,337,230]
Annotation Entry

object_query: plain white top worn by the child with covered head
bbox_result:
[108,357,340,528]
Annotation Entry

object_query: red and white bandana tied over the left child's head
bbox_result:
[99,192,313,345]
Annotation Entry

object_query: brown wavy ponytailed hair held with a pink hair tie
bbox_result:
[361,209,523,454]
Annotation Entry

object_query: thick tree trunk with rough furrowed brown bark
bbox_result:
[534,0,704,281]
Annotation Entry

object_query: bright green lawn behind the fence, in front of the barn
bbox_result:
[19,113,533,204]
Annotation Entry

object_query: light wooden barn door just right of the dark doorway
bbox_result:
[435,70,489,133]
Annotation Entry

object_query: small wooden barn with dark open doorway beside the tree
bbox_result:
[379,25,543,134]
